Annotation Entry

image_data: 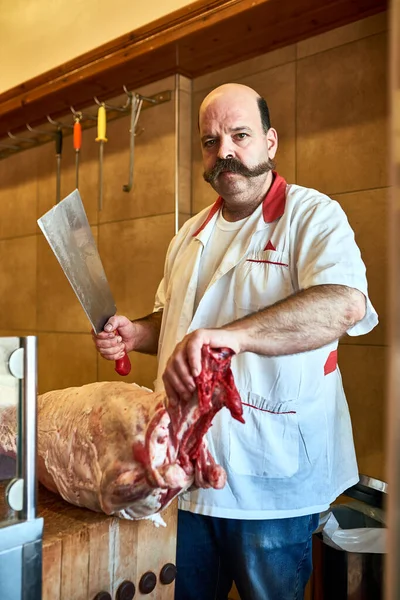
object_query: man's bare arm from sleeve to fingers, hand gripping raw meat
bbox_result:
[163,285,366,399]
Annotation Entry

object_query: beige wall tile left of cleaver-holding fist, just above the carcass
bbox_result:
[38,333,97,394]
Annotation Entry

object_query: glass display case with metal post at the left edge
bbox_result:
[0,336,43,600]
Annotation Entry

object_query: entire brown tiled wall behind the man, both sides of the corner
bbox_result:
[0,14,388,478]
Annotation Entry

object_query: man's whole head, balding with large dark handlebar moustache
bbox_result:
[199,83,277,204]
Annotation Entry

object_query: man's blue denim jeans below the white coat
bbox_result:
[175,510,318,600]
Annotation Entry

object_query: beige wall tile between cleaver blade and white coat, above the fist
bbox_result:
[99,214,174,319]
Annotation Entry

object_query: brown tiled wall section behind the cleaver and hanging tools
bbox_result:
[0,77,191,392]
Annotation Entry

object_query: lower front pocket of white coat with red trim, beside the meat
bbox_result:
[229,393,300,479]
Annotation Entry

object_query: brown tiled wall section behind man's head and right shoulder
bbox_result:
[192,13,389,478]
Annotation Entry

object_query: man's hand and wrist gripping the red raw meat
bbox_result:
[163,329,240,403]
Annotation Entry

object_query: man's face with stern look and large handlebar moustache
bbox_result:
[200,94,275,197]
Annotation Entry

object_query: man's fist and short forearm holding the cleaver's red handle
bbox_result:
[92,310,163,360]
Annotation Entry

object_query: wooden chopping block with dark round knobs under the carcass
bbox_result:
[38,487,177,600]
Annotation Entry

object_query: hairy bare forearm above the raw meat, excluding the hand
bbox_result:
[222,285,366,356]
